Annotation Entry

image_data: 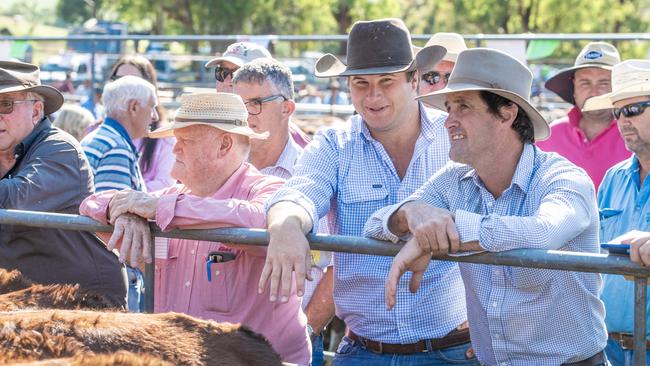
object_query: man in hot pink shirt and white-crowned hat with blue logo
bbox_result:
[537,42,630,189]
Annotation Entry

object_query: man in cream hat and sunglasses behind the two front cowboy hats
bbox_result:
[416,32,467,95]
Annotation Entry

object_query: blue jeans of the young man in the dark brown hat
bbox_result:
[334,336,478,366]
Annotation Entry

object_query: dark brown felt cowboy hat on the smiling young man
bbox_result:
[315,19,445,78]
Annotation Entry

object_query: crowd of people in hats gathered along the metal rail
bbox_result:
[0,19,650,366]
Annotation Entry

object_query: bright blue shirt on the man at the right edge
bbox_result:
[598,156,650,338]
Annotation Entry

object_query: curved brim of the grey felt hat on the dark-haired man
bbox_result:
[416,83,551,141]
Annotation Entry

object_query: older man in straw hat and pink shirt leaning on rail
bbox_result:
[81,93,310,364]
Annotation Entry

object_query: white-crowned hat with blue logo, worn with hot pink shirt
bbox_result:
[544,42,621,104]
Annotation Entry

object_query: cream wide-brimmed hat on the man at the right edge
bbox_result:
[582,60,650,112]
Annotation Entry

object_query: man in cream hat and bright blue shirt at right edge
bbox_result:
[584,60,650,365]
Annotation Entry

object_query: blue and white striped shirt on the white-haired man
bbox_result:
[81,118,146,192]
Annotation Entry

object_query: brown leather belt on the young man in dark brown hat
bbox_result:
[348,328,469,354]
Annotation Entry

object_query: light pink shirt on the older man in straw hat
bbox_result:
[80,163,311,365]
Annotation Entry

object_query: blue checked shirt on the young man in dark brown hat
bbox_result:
[267,107,467,344]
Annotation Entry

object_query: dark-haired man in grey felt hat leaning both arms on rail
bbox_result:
[364,48,607,365]
